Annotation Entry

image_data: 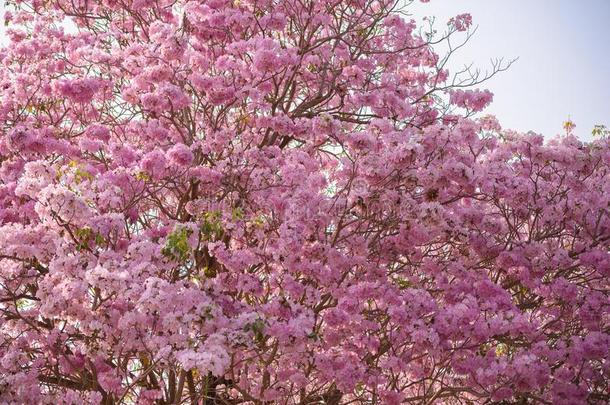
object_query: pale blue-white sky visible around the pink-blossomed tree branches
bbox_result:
[0,0,610,140]
